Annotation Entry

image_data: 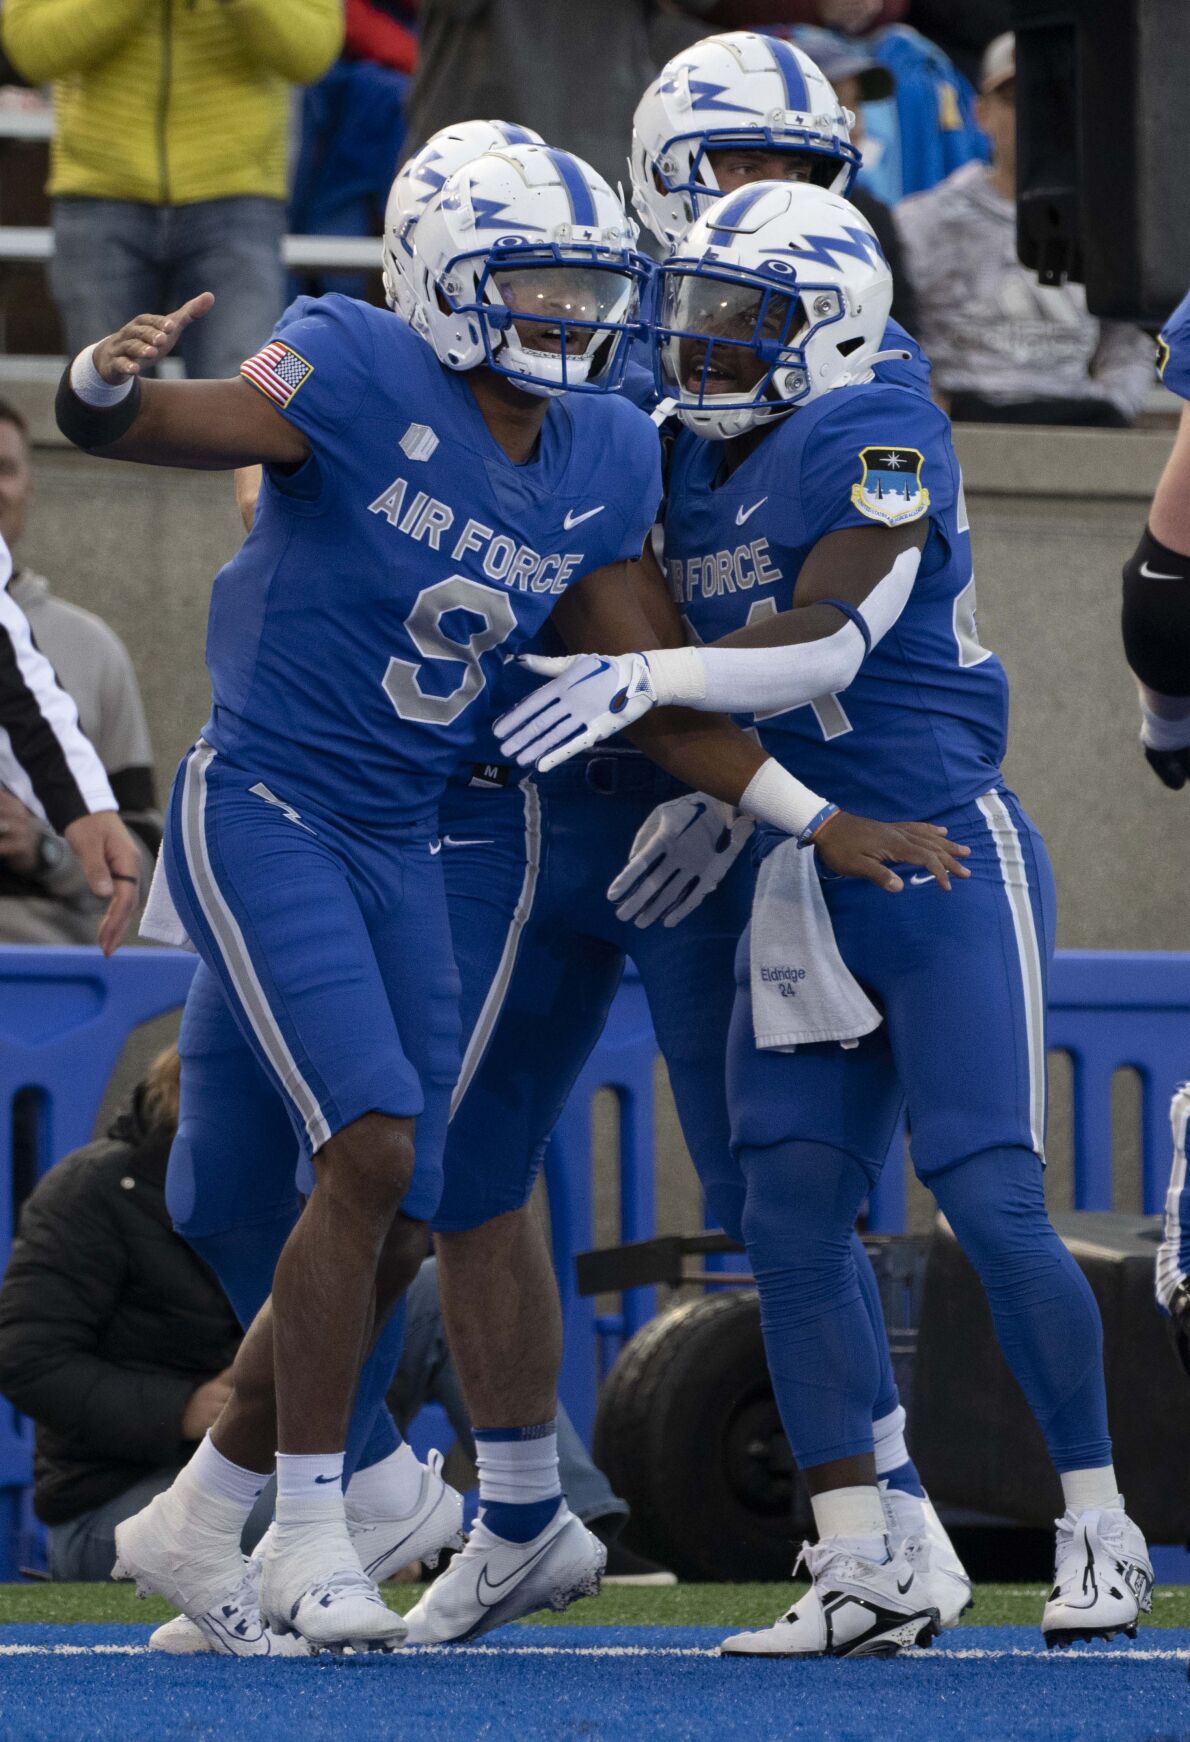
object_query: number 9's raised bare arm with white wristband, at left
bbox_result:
[56,291,310,470]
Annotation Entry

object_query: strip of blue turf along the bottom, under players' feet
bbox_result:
[0,1627,1190,1742]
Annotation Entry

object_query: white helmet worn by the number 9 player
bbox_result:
[409,145,652,394]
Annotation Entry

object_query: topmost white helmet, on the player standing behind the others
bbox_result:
[629,30,861,247]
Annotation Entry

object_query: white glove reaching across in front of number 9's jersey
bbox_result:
[495,653,657,773]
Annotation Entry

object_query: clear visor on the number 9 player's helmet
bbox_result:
[490,263,639,359]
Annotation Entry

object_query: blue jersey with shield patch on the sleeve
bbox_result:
[666,381,1009,820]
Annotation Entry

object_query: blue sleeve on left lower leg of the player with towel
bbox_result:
[737,1141,896,1470]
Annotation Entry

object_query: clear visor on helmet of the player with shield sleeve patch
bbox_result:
[659,272,807,401]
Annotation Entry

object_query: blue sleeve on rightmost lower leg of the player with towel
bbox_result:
[927,1148,1112,1474]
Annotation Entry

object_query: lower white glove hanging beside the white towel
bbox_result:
[608,793,754,930]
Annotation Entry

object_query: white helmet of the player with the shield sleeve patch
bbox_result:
[653,181,899,441]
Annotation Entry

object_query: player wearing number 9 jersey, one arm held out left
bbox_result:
[59,145,944,1648]
